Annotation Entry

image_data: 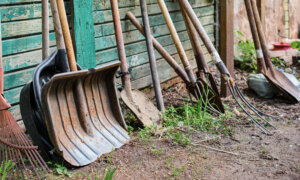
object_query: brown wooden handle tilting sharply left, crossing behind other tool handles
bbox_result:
[126,12,219,114]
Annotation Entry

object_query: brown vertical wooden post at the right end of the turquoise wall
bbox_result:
[219,0,234,97]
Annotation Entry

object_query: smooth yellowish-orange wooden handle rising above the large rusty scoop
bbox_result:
[56,0,77,71]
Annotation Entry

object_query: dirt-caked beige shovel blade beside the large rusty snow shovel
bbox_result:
[121,90,161,126]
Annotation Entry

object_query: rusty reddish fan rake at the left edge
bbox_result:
[0,17,50,179]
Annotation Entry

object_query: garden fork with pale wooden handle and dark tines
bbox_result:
[158,0,224,112]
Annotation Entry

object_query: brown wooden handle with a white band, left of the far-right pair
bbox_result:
[244,0,266,73]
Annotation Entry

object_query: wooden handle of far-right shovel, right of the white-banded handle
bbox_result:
[251,0,274,73]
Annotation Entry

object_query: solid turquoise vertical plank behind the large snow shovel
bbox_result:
[73,0,96,69]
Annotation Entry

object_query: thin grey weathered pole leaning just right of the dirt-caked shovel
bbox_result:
[140,0,165,111]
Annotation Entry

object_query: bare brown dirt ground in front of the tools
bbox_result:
[50,69,300,180]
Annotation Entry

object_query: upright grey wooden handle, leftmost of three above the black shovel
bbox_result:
[42,0,49,60]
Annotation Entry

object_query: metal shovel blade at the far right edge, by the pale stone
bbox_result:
[263,69,300,103]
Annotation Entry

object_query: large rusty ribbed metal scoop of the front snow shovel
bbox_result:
[42,62,130,166]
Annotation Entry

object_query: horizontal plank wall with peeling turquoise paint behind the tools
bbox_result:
[0,0,216,120]
